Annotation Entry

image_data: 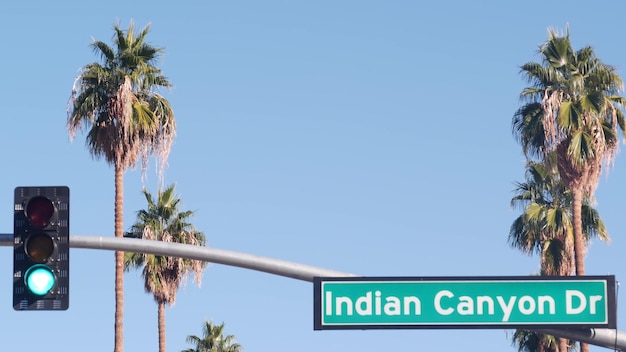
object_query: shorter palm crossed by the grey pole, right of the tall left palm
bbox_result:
[124,185,205,352]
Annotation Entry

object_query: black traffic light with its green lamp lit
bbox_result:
[13,186,70,310]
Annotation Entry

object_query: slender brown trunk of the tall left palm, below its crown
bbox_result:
[114,164,124,352]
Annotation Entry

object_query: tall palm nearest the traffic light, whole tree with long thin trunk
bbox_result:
[67,22,176,352]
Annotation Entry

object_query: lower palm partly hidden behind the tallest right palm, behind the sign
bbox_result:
[509,160,609,352]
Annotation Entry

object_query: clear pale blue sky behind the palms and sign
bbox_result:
[0,0,626,352]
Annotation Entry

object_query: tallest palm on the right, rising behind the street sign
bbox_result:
[513,29,626,275]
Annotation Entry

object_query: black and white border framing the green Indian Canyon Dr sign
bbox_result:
[313,275,617,330]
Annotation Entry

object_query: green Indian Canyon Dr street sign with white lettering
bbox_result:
[313,276,616,330]
